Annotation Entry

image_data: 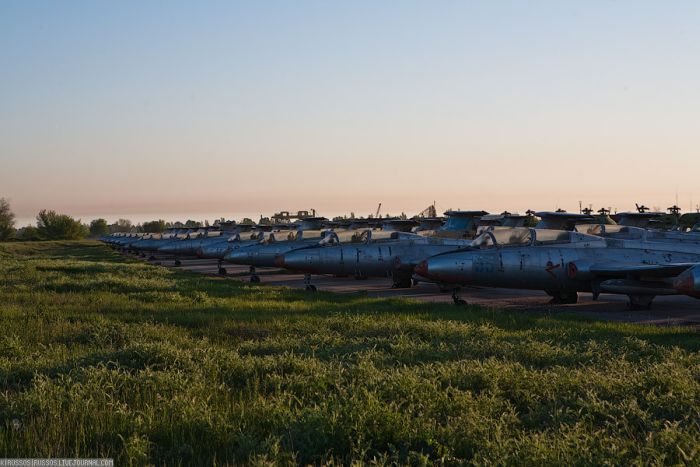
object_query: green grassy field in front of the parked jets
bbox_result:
[0,242,700,465]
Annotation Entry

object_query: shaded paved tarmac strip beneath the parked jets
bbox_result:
[138,256,700,329]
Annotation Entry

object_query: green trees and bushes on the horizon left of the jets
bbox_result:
[0,198,209,241]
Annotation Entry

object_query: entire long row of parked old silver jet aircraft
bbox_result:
[102,207,700,310]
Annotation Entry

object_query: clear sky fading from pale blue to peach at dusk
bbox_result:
[0,0,700,227]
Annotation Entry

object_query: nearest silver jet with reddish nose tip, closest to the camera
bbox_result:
[415,229,700,310]
